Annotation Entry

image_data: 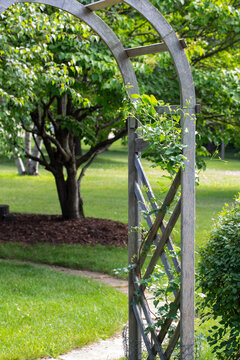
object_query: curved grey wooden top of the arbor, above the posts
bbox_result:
[0,0,195,108]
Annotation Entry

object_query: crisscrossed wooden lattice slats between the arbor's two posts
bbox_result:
[132,154,181,360]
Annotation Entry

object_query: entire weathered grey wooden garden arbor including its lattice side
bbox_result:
[0,0,196,360]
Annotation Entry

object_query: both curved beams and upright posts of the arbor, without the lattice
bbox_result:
[0,0,196,360]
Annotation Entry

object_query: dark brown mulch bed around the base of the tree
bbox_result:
[0,214,128,247]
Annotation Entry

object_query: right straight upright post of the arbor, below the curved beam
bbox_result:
[180,108,195,360]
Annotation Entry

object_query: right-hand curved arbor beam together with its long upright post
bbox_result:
[124,0,196,360]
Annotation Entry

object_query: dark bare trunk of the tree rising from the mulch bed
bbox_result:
[54,164,84,220]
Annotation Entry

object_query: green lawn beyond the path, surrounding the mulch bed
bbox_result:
[0,144,240,360]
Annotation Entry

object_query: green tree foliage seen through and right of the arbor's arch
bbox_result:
[100,0,240,155]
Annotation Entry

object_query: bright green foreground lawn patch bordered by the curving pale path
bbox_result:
[0,262,127,360]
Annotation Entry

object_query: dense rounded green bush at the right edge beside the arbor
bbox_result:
[199,194,240,360]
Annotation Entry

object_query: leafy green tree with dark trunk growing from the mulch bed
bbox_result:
[0,5,127,219]
